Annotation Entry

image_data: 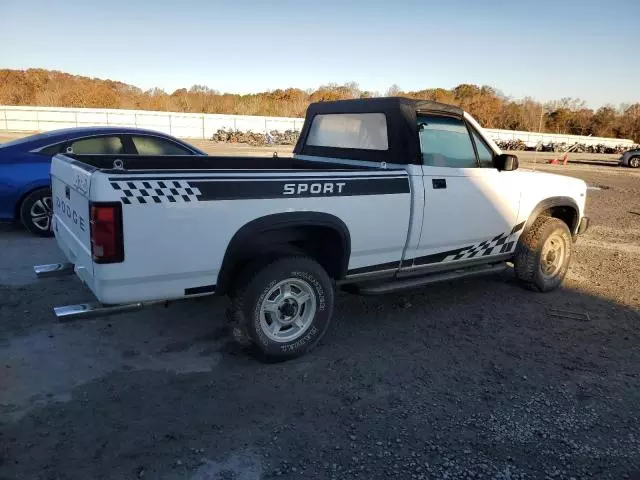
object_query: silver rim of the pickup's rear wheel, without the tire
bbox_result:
[260,278,316,342]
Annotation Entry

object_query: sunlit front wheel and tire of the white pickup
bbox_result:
[514,216,573,292]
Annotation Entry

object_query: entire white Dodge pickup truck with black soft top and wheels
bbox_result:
[35,98,588,357]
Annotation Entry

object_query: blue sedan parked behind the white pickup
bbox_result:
[0,127,206,236]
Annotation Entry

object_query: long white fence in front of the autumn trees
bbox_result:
[0,105,633,147]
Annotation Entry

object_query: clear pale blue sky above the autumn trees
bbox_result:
[0,0,640,107]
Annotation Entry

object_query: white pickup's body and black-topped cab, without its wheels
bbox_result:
[40,99,586,356]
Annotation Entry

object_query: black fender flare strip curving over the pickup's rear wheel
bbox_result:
[216,212,351,293]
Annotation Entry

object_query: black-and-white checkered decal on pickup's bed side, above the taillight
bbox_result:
[111,180,201,205]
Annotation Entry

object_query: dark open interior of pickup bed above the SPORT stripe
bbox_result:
[65,154,379,173]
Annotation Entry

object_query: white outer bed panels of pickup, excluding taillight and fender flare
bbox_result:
[51,161,421,304]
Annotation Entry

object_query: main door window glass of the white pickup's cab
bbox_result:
[418,115,478,168]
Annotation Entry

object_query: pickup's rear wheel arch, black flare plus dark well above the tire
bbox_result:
[216,212,351,294]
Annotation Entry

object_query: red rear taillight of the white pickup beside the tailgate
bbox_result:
[90,202,124,263]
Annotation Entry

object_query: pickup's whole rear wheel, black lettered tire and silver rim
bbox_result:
[229,256,334,360]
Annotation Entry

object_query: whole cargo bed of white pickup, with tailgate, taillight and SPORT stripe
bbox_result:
[51,154,410,304]
